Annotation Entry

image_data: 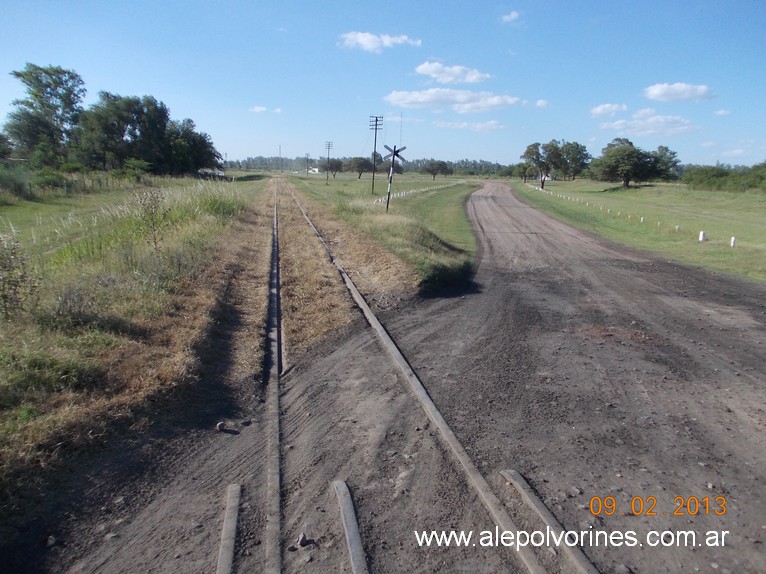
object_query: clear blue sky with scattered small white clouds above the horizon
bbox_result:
[0,0,766,165]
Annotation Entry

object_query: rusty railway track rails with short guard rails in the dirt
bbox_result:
[210,179,597,574]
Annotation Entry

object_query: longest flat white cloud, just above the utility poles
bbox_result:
[383,88,521,114]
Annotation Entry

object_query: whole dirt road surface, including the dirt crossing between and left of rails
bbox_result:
[30,183,766,573]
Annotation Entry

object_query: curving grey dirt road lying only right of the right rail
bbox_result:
[388,184,766,572]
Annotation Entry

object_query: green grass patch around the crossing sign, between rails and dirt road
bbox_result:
[291,174,479,292]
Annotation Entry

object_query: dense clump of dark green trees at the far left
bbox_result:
[0,64,222,175]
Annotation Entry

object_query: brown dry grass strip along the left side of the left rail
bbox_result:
[0,183,271,522]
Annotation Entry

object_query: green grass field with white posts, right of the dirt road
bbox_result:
[513,180,766,281]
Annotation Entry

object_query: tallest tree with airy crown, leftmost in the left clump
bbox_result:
[6,64,85,165]
